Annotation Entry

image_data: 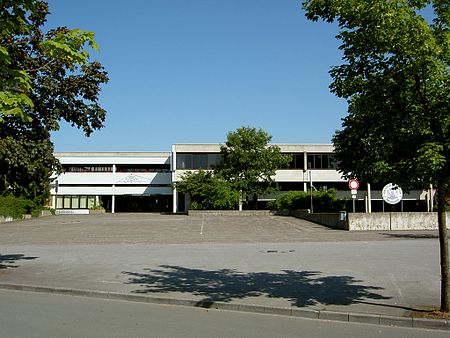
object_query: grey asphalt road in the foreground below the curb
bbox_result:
[0,290,448,338]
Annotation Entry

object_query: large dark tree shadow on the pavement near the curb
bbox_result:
[123,265,391,307]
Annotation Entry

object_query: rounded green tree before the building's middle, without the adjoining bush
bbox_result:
[216,127,291,207]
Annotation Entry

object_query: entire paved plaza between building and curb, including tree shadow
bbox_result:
[0,214,446,328]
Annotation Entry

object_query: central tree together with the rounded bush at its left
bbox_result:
[176,127,291,209]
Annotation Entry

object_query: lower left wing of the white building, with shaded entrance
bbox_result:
[51,152,173,213]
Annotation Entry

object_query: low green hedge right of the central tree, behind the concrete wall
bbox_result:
[268,189,347,212]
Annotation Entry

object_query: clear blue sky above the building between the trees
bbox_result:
[47,0,346,151]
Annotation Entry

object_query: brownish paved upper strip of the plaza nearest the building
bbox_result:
[0,213,438,245]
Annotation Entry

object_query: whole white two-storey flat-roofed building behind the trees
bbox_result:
[51,144,426,213]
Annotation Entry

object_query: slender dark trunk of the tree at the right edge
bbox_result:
[437,182,450,312]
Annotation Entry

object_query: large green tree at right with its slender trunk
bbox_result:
[303,0,450,312]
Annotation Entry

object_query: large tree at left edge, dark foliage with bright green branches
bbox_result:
[0,0,108,200]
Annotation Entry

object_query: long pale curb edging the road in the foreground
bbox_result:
[0,283,450,331]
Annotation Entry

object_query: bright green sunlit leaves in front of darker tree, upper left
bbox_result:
[0,0,103,123]
